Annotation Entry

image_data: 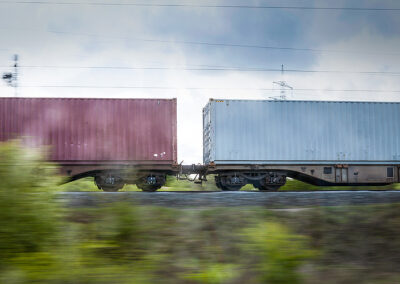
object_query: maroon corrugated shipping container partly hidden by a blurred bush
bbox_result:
[0,98,177,164]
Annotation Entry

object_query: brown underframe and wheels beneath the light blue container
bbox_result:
[204,163,400,191]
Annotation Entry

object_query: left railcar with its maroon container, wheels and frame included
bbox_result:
[0,98,177,191]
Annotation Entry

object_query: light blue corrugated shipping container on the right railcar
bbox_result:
[203,100,400,164]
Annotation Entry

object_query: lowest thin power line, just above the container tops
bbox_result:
[21,85,400,93]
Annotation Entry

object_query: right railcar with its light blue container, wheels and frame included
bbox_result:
[203,99,400,191]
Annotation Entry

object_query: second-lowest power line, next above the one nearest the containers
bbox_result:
[0,65,400,76]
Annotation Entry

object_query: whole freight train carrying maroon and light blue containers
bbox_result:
[0,98,400,191]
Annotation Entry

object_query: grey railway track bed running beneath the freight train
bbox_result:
[57,190,400,208]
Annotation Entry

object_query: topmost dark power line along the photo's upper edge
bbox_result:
[0,1,400,11]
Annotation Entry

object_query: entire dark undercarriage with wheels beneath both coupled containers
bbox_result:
[61,162,400,191]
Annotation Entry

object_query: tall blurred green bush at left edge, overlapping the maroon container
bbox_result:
[0,142,60,267]
